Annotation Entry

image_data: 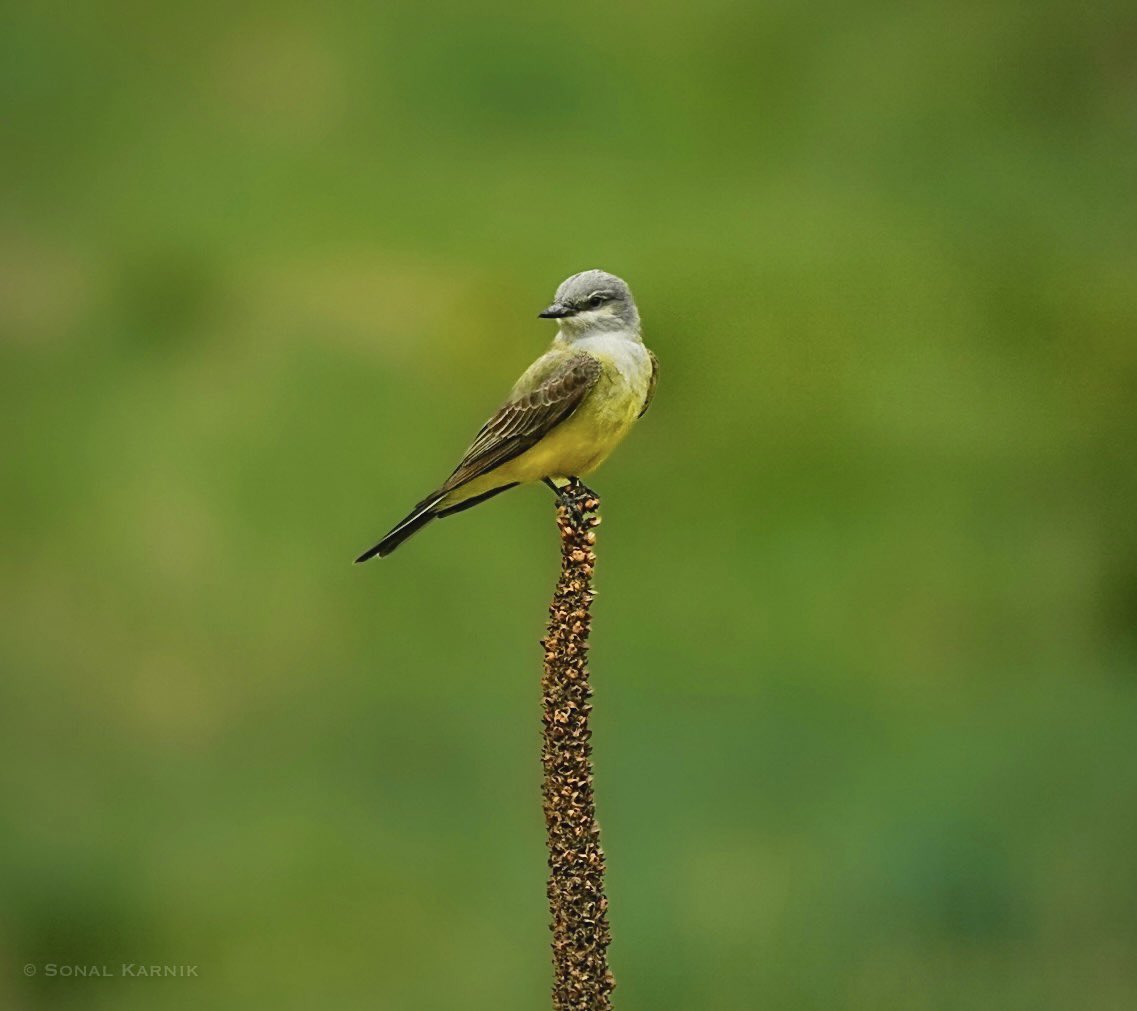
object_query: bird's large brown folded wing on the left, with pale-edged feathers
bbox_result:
[441,351,600,491]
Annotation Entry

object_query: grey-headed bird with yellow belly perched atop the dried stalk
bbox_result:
[356,270,659,563]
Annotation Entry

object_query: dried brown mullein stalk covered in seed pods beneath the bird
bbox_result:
[541,483,615,1011]
